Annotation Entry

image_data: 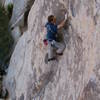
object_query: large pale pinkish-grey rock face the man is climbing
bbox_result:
[4,0,100,100]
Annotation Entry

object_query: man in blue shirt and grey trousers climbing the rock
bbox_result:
[45,14,67,61]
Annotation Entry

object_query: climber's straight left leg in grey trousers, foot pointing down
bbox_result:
[48,42,55,61]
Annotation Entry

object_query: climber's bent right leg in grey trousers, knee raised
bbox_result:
[53,41,66,55]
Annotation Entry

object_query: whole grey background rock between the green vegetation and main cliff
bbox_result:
[9,0,34,44]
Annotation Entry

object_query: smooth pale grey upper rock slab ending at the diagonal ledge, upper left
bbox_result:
[10,0,34,27]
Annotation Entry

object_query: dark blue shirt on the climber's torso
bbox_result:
[45,22,58,40]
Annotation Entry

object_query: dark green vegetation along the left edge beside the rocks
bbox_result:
[0,5,13,99]
